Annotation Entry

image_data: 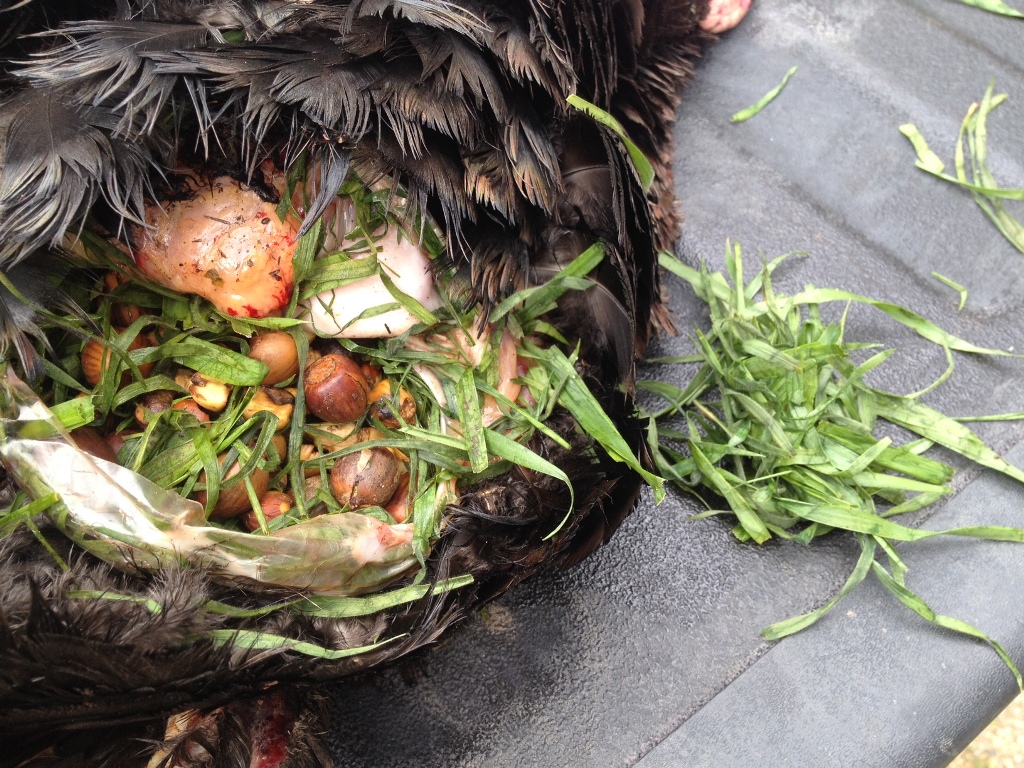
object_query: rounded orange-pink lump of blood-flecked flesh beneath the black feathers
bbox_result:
[134,176,299,317]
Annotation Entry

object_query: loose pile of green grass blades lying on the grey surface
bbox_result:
[638,246,1024,685]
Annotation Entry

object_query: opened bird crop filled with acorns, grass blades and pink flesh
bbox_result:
[0,164,658,630]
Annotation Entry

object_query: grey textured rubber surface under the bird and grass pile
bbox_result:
[334,0,1024,768]
